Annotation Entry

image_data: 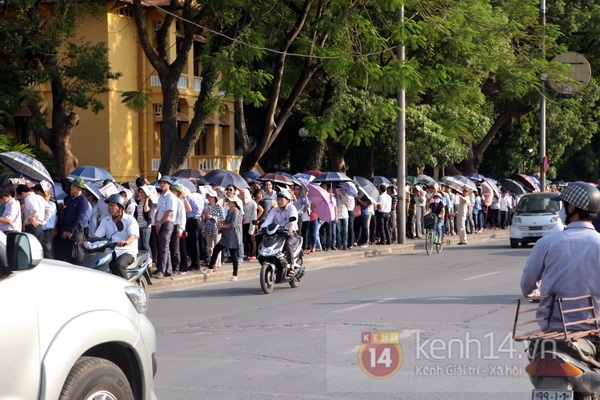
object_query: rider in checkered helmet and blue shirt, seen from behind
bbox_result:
[521,182,600,331]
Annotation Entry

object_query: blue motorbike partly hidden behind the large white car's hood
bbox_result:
[82,237,152,297]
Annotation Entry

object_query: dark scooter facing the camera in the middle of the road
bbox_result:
[258,217,305,294]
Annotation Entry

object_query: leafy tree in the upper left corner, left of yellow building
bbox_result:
[0,0,119,178]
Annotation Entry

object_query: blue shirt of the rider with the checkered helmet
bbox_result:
[521,221,600,331]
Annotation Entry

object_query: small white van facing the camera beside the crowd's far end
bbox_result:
[510,193,565,248]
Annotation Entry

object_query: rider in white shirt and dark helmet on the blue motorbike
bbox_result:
[93,194,140,279]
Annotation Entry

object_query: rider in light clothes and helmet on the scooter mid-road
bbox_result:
[260,190,300,276]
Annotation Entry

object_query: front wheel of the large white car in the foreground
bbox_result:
[59,357,134,400]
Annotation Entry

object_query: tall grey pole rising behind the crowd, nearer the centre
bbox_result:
[396,4,406,244]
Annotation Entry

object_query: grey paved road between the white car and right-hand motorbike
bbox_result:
[149,239,531,400]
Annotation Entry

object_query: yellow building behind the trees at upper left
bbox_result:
[15,2,241,181]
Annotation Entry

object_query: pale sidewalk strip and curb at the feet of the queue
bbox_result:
[148,229,509,291]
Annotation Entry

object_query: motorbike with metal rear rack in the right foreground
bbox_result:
[513,295,600,400]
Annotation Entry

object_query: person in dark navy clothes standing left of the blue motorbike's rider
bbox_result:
[60,178,90,265]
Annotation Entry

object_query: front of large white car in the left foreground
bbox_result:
[0,232,156,400]
